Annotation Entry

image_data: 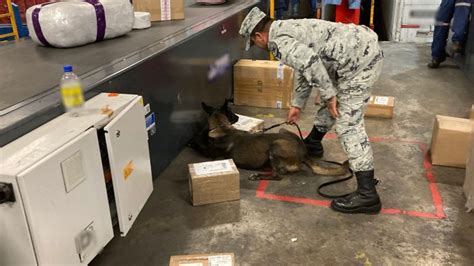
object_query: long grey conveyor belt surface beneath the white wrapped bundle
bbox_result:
[0,0,258,132]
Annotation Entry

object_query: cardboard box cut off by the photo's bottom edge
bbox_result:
[169,253,235,266]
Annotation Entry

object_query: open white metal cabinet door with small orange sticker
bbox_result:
[104,97,153,236]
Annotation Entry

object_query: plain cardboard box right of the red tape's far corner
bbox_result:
[431,115,473,168]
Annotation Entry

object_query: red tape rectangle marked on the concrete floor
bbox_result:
[256,132,446,219]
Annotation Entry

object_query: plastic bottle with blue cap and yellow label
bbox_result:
[60,65,84,116]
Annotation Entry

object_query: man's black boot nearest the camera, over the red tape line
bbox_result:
[331,170,382,213]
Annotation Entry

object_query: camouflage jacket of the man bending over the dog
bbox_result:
[268,19,381,108]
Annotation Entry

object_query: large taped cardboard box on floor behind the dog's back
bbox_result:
[234,59,293,108]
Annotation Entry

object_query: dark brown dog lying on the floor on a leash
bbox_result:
[203,104,349,180]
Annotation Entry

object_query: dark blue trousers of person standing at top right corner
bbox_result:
[431,0,471,60]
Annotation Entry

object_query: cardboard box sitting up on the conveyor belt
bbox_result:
[133,0,184,21]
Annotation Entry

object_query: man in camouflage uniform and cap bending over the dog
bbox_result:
[239,8,383,213]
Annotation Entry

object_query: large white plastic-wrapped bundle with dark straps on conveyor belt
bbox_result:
[26,0,134,48]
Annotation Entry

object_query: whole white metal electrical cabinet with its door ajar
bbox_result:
[0,93,153,265]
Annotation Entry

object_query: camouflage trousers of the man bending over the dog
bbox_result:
[314,57,383,172]
